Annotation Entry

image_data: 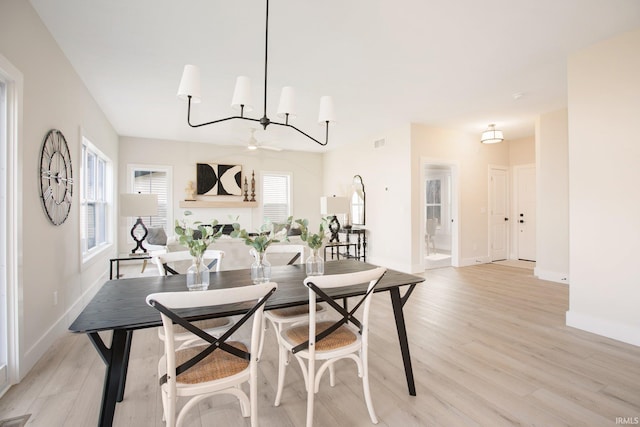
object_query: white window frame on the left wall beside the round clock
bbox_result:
[78,134,114,265]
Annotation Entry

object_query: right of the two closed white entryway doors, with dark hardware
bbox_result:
[516,166,536,261]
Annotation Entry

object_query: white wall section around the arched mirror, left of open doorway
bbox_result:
[324,125,412,271]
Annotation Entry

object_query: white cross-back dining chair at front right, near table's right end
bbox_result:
[275,267,386,427]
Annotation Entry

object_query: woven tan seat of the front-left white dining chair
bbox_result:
[176,341,249,384]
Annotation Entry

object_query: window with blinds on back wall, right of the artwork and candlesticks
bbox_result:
[262,172,291,223]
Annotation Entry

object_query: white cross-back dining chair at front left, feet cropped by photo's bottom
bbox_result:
[146,282,278,427]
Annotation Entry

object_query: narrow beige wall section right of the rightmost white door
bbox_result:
[535,109,569,283]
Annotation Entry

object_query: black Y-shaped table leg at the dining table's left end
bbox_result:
[88,329,130,427]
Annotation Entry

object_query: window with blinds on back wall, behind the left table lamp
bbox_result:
[128,165,173,231]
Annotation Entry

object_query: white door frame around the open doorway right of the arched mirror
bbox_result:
[419,157,460,270]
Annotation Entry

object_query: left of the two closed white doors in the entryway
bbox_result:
[489,167,509,261]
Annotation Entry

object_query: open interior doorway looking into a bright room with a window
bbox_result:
[421,161,458,269]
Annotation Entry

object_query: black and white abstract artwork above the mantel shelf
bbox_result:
[197,163,242,196]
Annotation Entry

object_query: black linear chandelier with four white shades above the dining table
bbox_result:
[178,0,335,146]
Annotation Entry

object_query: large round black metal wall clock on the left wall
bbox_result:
[40,129,73,225]
